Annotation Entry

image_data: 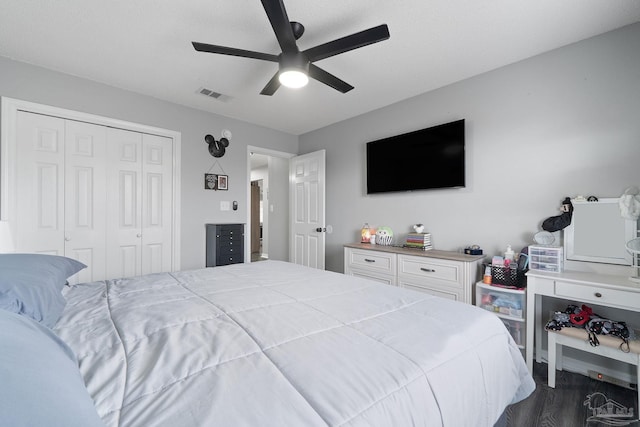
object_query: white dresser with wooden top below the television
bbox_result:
[344,243,483,304]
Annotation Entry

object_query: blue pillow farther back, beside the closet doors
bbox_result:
[0,254,87,328]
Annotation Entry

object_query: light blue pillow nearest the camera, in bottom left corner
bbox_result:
[0,310,104,427]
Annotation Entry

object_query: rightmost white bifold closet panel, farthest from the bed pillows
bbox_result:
[142,134,173,274]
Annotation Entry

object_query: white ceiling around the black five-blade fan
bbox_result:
[0,0,640,135]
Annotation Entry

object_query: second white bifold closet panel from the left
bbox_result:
[64,120,107,282]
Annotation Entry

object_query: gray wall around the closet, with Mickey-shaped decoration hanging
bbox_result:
[0,57,298,269]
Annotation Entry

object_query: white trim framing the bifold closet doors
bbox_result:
[0,97,182,271]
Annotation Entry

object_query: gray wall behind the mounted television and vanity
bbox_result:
[299,24,640,271]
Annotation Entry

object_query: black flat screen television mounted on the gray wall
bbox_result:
[367,119,465,194]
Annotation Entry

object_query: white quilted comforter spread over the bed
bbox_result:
[56,261,535,427]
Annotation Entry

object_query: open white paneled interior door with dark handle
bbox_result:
[289,150,326,270]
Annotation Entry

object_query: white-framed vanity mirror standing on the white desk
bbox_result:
[564,198,638,265]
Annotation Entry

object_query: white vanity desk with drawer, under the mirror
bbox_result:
[525,270,640,372]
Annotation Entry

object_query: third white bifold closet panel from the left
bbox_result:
[106,128,142,278]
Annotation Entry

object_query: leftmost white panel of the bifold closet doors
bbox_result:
[15,111,64,255]
